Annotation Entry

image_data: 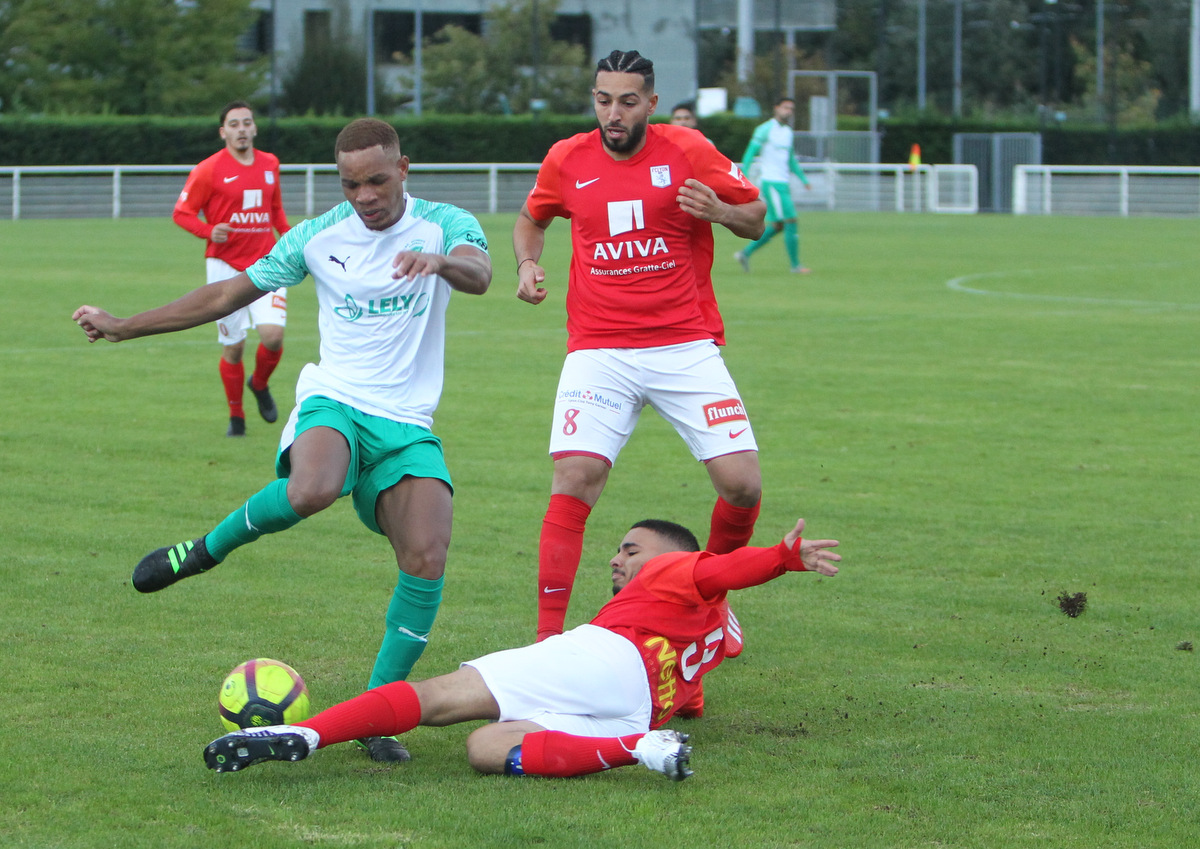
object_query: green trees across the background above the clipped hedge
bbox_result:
[0,0,1192,126]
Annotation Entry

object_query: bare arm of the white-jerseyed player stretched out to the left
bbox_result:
[71,273,263,342]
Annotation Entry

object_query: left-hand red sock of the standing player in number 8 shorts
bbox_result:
[538,495,592,640]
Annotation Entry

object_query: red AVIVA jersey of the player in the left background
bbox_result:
[172,147,288,271]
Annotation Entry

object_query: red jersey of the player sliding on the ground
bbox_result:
[592,542,805,728]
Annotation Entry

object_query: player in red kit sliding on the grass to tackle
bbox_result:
[204,519,841,781]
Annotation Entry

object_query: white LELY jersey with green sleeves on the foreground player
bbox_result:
[246,194,487,428]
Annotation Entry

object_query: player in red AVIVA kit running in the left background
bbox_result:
[173,101,288,436]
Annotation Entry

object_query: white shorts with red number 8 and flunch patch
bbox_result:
[550,341,758,464]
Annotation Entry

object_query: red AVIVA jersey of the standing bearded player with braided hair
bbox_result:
[526,124,758,351]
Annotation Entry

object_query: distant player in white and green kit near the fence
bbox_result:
[733,97,812,275]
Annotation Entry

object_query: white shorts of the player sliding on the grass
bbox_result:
[462,625,652,737]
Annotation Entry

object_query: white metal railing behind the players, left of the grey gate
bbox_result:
[0,162,978,219]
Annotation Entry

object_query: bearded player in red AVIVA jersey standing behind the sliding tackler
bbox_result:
[512,50,766,695]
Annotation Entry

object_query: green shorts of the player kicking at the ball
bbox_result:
[275,395,454,534]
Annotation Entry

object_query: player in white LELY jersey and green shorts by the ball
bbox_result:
[74,119,492,760]
